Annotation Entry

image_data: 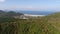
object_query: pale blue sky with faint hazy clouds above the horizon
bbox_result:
[0,0,60,11]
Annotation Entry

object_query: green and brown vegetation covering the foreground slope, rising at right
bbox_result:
[0,13,60,34]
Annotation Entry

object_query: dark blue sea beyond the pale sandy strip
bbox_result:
[18,11,54,15]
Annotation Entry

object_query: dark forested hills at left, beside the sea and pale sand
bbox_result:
[0,10,23,17]
